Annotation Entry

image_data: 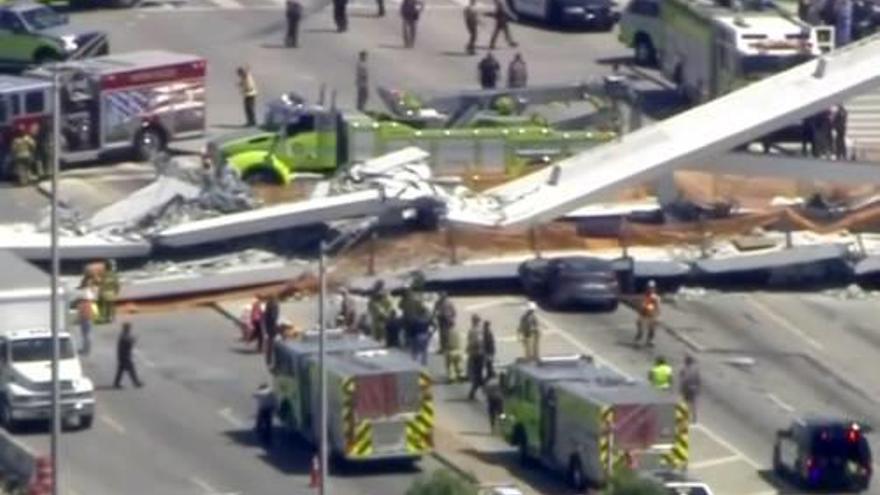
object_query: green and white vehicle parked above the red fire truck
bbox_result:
[0,1,110,67]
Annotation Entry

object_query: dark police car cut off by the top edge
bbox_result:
[509,0,620,31]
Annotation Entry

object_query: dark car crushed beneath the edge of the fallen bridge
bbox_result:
[519,256,620,311]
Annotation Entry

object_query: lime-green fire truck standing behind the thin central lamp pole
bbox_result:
[273,331,434,462]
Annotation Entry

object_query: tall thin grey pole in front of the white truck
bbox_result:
[49,67,61,495]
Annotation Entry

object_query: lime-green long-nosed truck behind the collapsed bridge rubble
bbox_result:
[205,84,618,184]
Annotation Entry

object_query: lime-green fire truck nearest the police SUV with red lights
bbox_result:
[500,356,689,490]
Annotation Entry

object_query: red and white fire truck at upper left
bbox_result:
[0,51,207,179]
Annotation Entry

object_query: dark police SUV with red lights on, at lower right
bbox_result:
[773,417,872,492]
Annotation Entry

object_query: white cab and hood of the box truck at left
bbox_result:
[0,329,95,430]
